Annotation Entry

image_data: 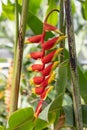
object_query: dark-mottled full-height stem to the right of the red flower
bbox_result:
[65,0,83,130]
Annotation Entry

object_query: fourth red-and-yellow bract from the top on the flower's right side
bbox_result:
[41,61,60,76]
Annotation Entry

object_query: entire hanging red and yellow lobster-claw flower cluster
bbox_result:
[25,10,66,117]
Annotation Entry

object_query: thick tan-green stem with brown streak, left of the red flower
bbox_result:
[10,0,29,114]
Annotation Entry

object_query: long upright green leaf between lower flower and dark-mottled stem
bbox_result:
[49,61,68,126]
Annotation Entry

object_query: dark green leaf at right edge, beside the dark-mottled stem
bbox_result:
[78,65,87,103]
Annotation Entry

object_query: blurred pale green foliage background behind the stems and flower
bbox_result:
[0,0,87,128]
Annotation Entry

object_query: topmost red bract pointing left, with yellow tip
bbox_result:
[24,34,42,44]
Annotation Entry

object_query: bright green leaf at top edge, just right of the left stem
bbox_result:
[29,0,42,14]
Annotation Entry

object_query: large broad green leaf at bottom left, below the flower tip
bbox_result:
[7,108,34,130]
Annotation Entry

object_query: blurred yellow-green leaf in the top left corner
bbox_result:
[2,2,15,20]
